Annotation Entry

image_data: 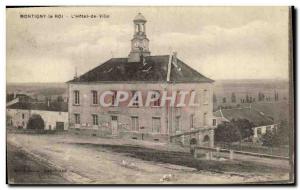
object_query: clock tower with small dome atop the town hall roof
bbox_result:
[128,13,150,62]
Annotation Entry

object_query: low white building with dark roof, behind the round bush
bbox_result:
[6,99,69,131]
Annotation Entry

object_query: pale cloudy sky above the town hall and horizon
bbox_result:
[6,7,289,83]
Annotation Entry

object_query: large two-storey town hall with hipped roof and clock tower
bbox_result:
[68,13,215,146]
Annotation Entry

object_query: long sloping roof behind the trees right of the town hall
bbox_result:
[214,108,274,126]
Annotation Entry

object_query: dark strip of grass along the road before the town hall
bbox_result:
[73,143,288,173]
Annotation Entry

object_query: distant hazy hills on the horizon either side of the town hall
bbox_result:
[6,79,289,105]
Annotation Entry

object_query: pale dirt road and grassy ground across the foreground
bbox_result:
[7,133,289,184]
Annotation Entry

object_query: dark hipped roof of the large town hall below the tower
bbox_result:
[68,55,213,83]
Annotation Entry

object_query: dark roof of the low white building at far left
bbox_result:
[7,102,68,112]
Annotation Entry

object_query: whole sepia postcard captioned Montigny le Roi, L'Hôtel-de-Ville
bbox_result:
[6,6,295,185]
